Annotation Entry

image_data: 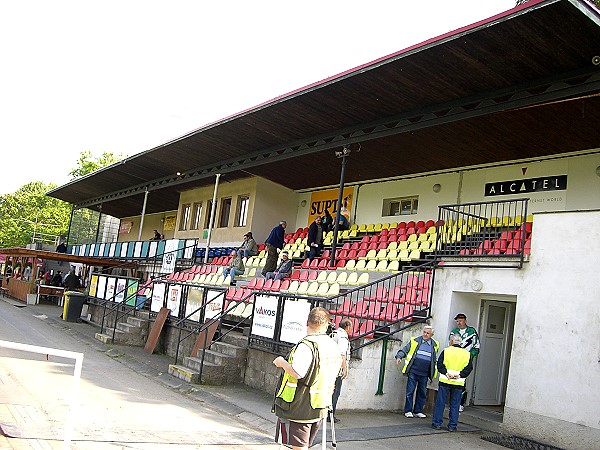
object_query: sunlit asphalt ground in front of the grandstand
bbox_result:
[0,299,504,450]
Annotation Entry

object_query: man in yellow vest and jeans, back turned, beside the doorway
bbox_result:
[431,334,473,431]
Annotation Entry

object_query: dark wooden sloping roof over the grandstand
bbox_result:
[48,0,600,217]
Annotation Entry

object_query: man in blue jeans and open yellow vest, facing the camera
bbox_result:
[396,325,440,418]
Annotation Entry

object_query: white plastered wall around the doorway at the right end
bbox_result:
[432,210,600,449]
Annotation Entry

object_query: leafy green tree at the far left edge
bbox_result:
[0,181,71,248]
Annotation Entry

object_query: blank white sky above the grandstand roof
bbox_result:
[0,0,515,195]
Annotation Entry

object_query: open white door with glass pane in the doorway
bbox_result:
[473,300,514,405]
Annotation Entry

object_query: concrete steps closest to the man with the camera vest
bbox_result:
[169,333,248,385]
